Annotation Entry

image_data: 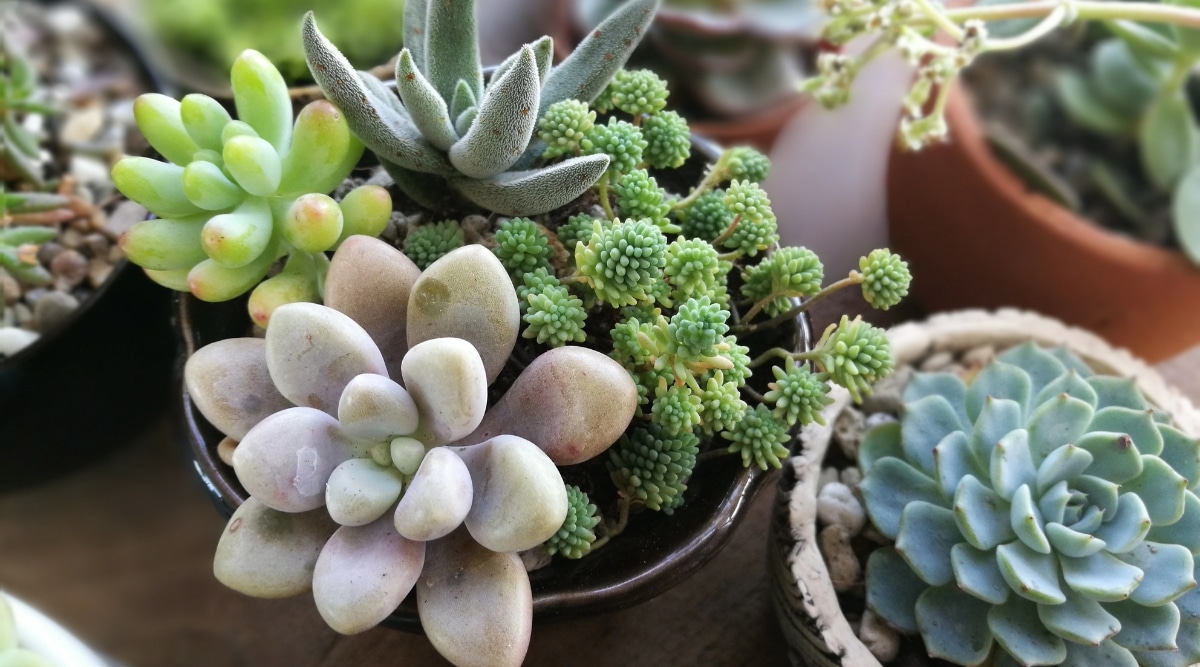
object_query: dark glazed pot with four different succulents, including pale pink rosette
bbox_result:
[114,0,908,665]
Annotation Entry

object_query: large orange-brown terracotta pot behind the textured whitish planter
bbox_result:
[887,91,1200,362]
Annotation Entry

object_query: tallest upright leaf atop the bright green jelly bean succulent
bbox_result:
[229,49,292,154]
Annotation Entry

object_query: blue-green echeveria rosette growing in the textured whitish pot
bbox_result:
[859,344,1200,666]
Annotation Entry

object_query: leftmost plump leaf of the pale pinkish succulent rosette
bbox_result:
[184,338,292,440]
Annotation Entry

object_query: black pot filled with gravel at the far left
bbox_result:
[0,2,178,491]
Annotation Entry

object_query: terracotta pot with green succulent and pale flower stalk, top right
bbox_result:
[796,4,1200,360]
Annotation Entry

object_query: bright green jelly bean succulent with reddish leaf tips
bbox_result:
[113,50,391,326]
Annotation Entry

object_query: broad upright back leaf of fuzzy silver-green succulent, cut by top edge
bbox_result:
[422,0,484,100]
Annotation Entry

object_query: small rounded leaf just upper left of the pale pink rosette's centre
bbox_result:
[337,373,421,441]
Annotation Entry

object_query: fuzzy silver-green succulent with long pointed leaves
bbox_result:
[297,0,659,216]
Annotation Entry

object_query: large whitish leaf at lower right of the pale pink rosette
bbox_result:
[455,435,566,552]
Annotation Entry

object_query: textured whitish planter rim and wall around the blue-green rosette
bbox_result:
[768,310,1200,667]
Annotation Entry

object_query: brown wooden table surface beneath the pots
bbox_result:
[9,298,1200,667]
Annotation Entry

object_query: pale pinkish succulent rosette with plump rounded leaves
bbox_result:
[185,236,637,665]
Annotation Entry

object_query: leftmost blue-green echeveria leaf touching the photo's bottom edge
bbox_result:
[916,585,992,665]
